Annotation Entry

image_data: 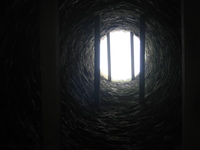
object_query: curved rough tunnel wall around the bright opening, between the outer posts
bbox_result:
[60,1,181,149]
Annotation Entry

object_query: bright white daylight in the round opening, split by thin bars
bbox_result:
[100,30,140,81]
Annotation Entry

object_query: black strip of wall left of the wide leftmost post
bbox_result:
[0,0,42,150]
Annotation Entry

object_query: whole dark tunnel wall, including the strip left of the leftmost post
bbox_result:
[0,0,182,150]
